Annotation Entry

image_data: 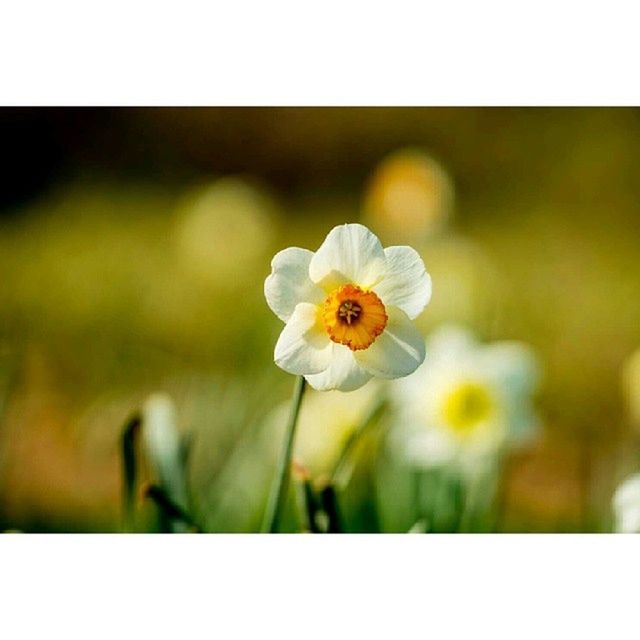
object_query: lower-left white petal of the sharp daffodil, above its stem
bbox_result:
[274,302,333,375]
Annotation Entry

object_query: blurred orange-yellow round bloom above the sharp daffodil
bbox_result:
[364,149,453,244]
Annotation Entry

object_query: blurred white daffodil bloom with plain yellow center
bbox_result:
[392,327,539,467]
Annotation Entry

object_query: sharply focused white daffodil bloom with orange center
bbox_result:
[264,224,431,391]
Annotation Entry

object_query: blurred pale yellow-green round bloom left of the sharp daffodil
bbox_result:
[176,177,276,285]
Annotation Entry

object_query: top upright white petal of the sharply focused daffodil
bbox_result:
[309,224,386,289]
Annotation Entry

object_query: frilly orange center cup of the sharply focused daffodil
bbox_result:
[322,284,387,351]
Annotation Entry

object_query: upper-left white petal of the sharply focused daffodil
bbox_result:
[264,247,324,322]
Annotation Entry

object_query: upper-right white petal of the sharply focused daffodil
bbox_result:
[374,247,431,320]
